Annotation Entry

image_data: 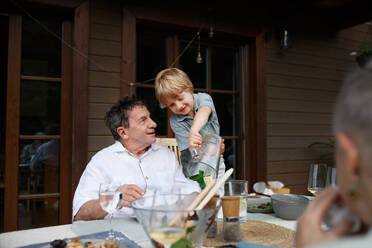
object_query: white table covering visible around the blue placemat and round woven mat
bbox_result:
[0,213,296,248]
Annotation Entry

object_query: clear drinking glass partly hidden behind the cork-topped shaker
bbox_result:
[225,180,248,222]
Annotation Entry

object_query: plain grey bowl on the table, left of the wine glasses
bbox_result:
[271,194,309,220]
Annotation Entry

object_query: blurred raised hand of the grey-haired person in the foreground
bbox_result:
[296,187,351,248]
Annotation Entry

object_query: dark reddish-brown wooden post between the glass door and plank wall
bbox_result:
[71,0,90,197]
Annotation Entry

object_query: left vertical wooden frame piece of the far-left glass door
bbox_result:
[4,15,22,232]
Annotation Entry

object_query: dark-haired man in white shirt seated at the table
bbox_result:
[73,97,200,220]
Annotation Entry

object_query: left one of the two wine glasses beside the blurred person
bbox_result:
[307,163,327,195]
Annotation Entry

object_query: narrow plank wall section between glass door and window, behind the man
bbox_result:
[88,0,122,160]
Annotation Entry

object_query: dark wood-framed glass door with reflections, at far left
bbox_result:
[5,13,72,230]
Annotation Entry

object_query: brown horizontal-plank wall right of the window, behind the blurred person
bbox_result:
[265,24,371,193]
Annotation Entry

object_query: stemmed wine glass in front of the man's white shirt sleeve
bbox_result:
[99,183,122,240]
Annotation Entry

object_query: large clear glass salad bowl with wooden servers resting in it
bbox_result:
[131,194,221,248]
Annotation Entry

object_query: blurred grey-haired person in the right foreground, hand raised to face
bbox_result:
[296,62,372,248]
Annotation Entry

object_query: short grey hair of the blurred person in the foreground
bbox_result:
[333,61,372,159]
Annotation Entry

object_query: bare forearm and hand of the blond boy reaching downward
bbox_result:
[189,106,212,148]
